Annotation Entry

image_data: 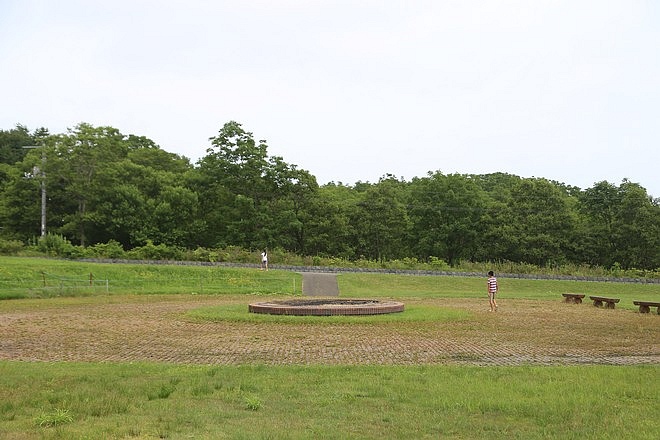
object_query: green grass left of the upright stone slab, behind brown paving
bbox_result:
[0,257,302,299]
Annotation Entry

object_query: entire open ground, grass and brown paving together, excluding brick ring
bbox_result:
[0,258,660,439]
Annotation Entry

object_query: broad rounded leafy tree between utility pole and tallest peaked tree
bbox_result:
[38,123,203,248]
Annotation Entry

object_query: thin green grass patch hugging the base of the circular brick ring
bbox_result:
[186,304,471,325]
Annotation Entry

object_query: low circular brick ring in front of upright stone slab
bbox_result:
[248,299,403,316]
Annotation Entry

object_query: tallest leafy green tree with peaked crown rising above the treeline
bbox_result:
[196,121,318,251]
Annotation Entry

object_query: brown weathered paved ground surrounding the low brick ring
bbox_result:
[0,295,660,365]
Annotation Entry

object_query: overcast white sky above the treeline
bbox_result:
[0,0,660,197]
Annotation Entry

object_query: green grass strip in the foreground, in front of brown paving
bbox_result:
[0,362,660,439]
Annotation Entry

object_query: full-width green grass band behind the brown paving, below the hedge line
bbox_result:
[0,256,660,309]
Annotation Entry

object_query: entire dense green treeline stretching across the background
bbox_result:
[0,121,660,270]
